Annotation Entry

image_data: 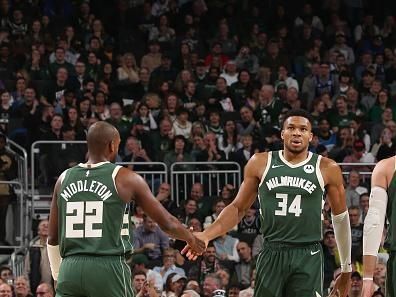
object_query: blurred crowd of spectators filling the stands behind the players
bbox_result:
[0,0,396,297]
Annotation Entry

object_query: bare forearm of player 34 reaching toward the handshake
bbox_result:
[204,203,244,241]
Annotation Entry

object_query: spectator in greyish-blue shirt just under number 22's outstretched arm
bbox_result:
[133,215,169,267]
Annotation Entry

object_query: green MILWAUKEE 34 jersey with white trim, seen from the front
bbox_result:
[258,151,324,244]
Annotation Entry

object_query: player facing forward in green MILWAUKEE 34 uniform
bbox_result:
[183,110,352,297]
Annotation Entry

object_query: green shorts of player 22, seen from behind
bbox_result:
[56,255,133,297]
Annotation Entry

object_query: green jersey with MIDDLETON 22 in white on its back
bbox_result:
[57,162,132,257]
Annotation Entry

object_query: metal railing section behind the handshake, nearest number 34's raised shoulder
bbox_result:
[170,162,241,205]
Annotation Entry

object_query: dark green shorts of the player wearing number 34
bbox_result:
[254,243,323,297]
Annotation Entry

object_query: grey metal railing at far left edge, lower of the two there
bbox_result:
[0,181,26,250]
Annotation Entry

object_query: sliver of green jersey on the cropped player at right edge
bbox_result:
[385,157,396,251]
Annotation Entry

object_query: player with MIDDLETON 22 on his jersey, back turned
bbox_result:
[48,122,205,297]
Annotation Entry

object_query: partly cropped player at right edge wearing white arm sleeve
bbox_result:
[362,157,396,297]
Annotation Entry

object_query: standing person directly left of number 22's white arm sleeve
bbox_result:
[25,220,52,292]
